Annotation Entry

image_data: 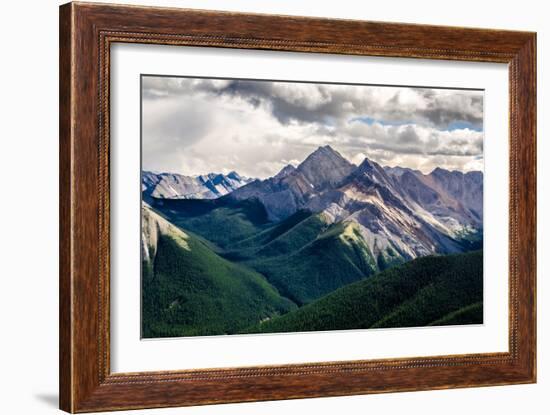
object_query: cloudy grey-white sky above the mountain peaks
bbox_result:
[142,76,483,178]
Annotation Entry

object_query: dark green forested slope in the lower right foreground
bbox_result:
[246,251,483,333]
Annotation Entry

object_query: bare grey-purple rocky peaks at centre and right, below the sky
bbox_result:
[228,146,483,259]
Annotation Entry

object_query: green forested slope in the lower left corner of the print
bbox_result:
[142,218,295,337]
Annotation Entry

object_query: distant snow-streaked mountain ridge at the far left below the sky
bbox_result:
[141,171,251,199]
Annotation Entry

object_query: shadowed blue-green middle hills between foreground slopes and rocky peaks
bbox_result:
[152,198,392,305]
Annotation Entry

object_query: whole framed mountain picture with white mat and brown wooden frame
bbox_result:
[60,3,536,412]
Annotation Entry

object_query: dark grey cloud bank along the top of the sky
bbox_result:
[143,77,483,129]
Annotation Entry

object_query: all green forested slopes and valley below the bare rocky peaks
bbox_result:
[142,192,483,337]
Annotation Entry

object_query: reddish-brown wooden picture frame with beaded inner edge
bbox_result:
[59,3,536,412]
